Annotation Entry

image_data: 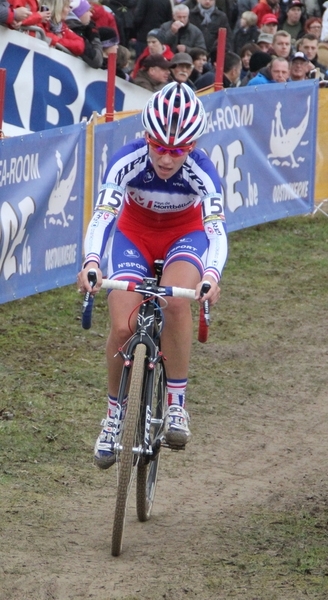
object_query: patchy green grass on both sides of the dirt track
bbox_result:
[0,215,328,600]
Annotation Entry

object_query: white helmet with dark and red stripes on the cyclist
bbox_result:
[142,82,207,146]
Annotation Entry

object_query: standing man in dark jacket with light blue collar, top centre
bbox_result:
[189,0,233,52]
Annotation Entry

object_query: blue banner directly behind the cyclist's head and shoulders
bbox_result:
[94,81,318,231]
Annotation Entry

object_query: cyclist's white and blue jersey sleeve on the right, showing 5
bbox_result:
[184,150,228,281]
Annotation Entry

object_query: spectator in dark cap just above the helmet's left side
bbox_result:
[133,54,170,93]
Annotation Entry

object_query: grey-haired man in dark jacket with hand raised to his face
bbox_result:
[161,4,206,53]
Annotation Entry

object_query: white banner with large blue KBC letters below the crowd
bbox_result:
[0,26,151,136]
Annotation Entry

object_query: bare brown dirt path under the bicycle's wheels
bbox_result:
[0,386,328,600]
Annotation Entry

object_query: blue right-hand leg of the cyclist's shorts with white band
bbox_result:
[163,231,208,287]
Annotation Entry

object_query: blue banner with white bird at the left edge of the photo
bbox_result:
[0,123,86,303]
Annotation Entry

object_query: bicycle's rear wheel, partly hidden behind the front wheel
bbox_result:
[137,362,166,521]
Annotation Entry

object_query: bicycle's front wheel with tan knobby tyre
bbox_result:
[112,344,146,556]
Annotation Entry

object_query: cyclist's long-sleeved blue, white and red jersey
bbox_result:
[84,139,227,281]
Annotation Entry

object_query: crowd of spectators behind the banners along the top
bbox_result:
[0,0,328,92]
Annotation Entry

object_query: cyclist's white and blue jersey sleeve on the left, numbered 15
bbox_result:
[84,140,147,265]
